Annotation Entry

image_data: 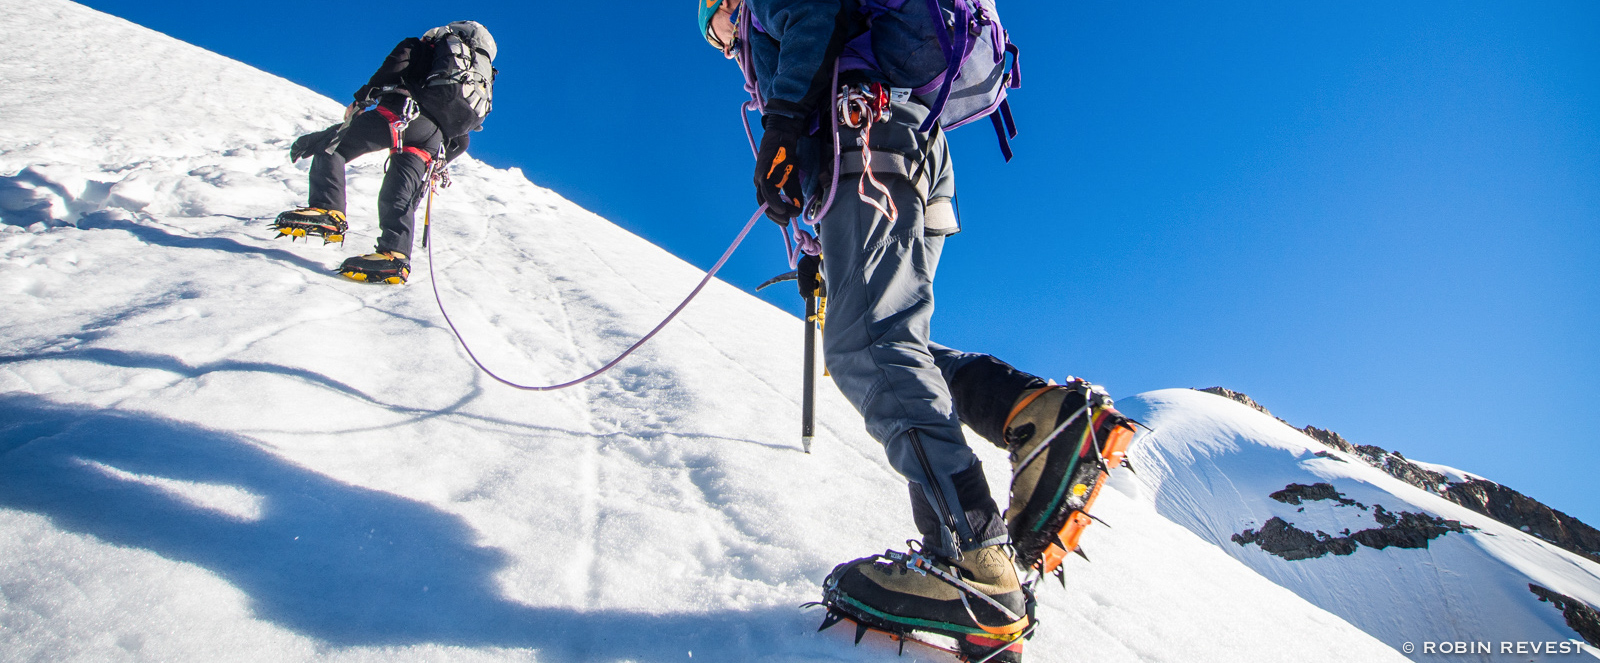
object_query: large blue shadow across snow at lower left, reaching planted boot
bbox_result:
[0,394,825,661]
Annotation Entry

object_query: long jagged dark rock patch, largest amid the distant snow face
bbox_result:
[1230,506,1472,562]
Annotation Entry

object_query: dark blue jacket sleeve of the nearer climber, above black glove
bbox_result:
[746,0,856,117]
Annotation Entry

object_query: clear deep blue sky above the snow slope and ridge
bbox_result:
[86,0,1600,525]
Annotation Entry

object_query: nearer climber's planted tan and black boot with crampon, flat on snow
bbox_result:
[822,546,1034,663]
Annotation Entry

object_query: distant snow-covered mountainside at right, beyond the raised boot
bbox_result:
[1118,389,1600,660]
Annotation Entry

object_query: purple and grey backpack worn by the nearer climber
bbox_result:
[838,0,1022,162]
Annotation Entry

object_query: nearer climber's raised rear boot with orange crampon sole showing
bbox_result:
[1005,380,1133,573]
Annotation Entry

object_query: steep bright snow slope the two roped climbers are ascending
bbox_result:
[0,0,1402,663]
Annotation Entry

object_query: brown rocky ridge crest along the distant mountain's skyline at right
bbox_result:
[1198,386,1600,562]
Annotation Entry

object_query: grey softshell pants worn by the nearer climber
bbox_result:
[810,95,1045,557]
